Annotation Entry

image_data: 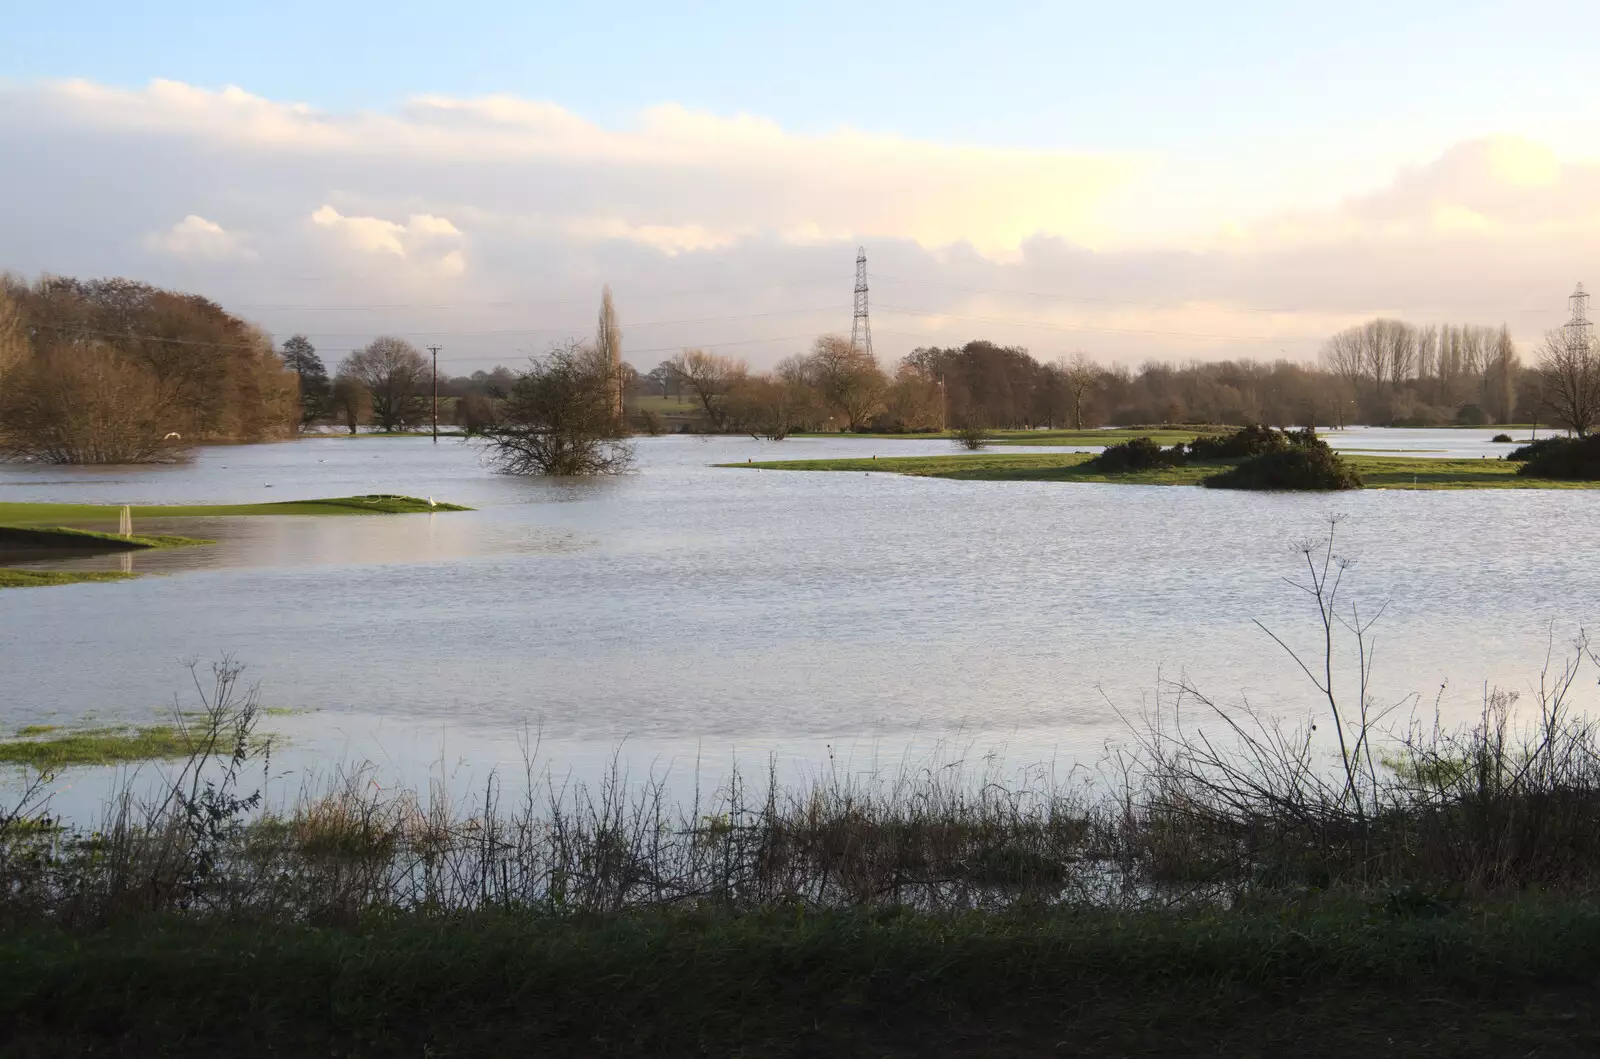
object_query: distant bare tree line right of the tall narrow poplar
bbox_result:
[620,320,1561,437]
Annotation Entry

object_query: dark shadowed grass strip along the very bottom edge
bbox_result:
[0,901,1600,1059]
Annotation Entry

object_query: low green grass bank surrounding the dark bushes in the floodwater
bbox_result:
[723,453,1600,490]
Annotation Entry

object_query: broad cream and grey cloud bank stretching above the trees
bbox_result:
[0,82,1600,370]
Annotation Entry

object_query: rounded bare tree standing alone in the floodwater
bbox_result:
[480,342,634,475]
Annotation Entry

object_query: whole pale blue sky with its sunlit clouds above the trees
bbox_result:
[0,0,1600,373]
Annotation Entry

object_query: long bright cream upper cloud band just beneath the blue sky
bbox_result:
[15,80,1139,254]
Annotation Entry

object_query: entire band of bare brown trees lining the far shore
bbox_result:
[0,277,1600,462]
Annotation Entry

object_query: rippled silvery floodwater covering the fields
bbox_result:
[0,429,1600,815]
